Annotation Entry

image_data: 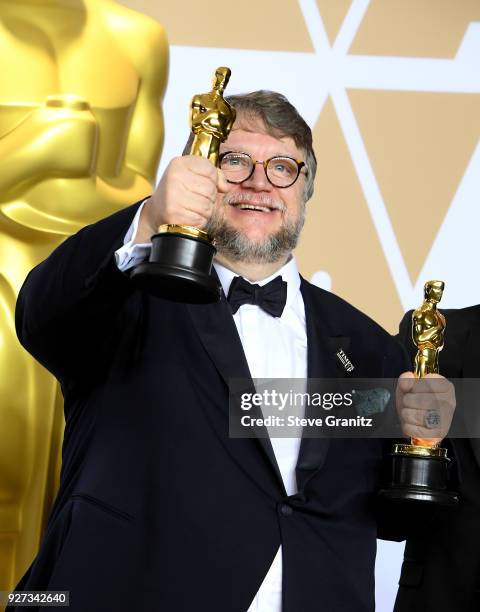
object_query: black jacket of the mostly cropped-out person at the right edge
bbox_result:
[395,305,480,612]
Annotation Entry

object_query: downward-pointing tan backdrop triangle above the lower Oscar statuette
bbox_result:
[348,90,480,284]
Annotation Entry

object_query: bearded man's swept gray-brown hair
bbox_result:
[183,90,317,202]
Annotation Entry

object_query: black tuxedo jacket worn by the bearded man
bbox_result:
[16,206,414,612]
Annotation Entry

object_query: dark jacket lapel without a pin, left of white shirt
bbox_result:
[186,292,285,494]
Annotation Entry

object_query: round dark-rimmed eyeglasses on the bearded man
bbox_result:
[219,151,307,189]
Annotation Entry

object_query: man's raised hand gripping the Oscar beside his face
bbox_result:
[134,155,228,243]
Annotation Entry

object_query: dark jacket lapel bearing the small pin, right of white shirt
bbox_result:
[295,278,350,491]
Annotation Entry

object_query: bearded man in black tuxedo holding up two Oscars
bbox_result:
[11,91,454,612]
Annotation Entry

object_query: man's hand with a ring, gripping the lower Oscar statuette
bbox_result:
[396,372,455,446]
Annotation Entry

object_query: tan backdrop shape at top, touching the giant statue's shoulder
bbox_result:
[114,0,314,52]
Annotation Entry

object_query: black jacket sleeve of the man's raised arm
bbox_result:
[15,204,145,386]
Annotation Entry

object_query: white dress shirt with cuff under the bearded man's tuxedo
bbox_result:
[115,207,307,612]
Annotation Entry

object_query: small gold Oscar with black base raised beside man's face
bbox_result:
[132,67,235,303]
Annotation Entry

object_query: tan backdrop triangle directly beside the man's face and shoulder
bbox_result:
[296,95,403,324]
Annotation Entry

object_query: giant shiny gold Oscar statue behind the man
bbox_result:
[0,0,168,590]
